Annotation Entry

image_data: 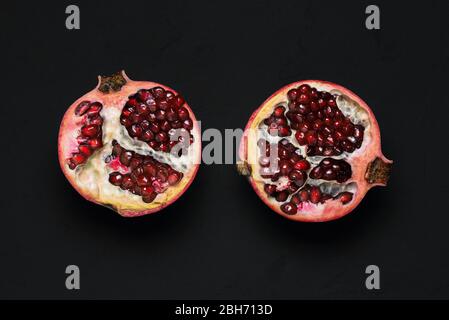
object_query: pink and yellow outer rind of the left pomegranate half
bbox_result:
[58,72,201,217]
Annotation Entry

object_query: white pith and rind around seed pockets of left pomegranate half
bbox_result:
[59,79,201,216]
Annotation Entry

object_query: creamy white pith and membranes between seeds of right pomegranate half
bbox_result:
[247,82,372,215]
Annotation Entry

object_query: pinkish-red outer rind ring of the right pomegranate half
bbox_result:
[239,80,392,222]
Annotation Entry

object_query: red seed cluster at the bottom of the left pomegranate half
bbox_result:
[106,140,183,203]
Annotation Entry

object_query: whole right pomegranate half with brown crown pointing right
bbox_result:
[237,80,392,222]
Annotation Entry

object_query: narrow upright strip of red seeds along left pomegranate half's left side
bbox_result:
[67,101,103,170]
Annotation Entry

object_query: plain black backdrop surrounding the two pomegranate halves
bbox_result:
[0,0,449,299]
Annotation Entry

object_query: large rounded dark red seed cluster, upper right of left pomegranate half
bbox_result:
[120,87,193,155]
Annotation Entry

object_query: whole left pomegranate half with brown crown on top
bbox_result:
[58,72,201,217]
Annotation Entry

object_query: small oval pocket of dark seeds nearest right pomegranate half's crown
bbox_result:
[310,158,352,183]
